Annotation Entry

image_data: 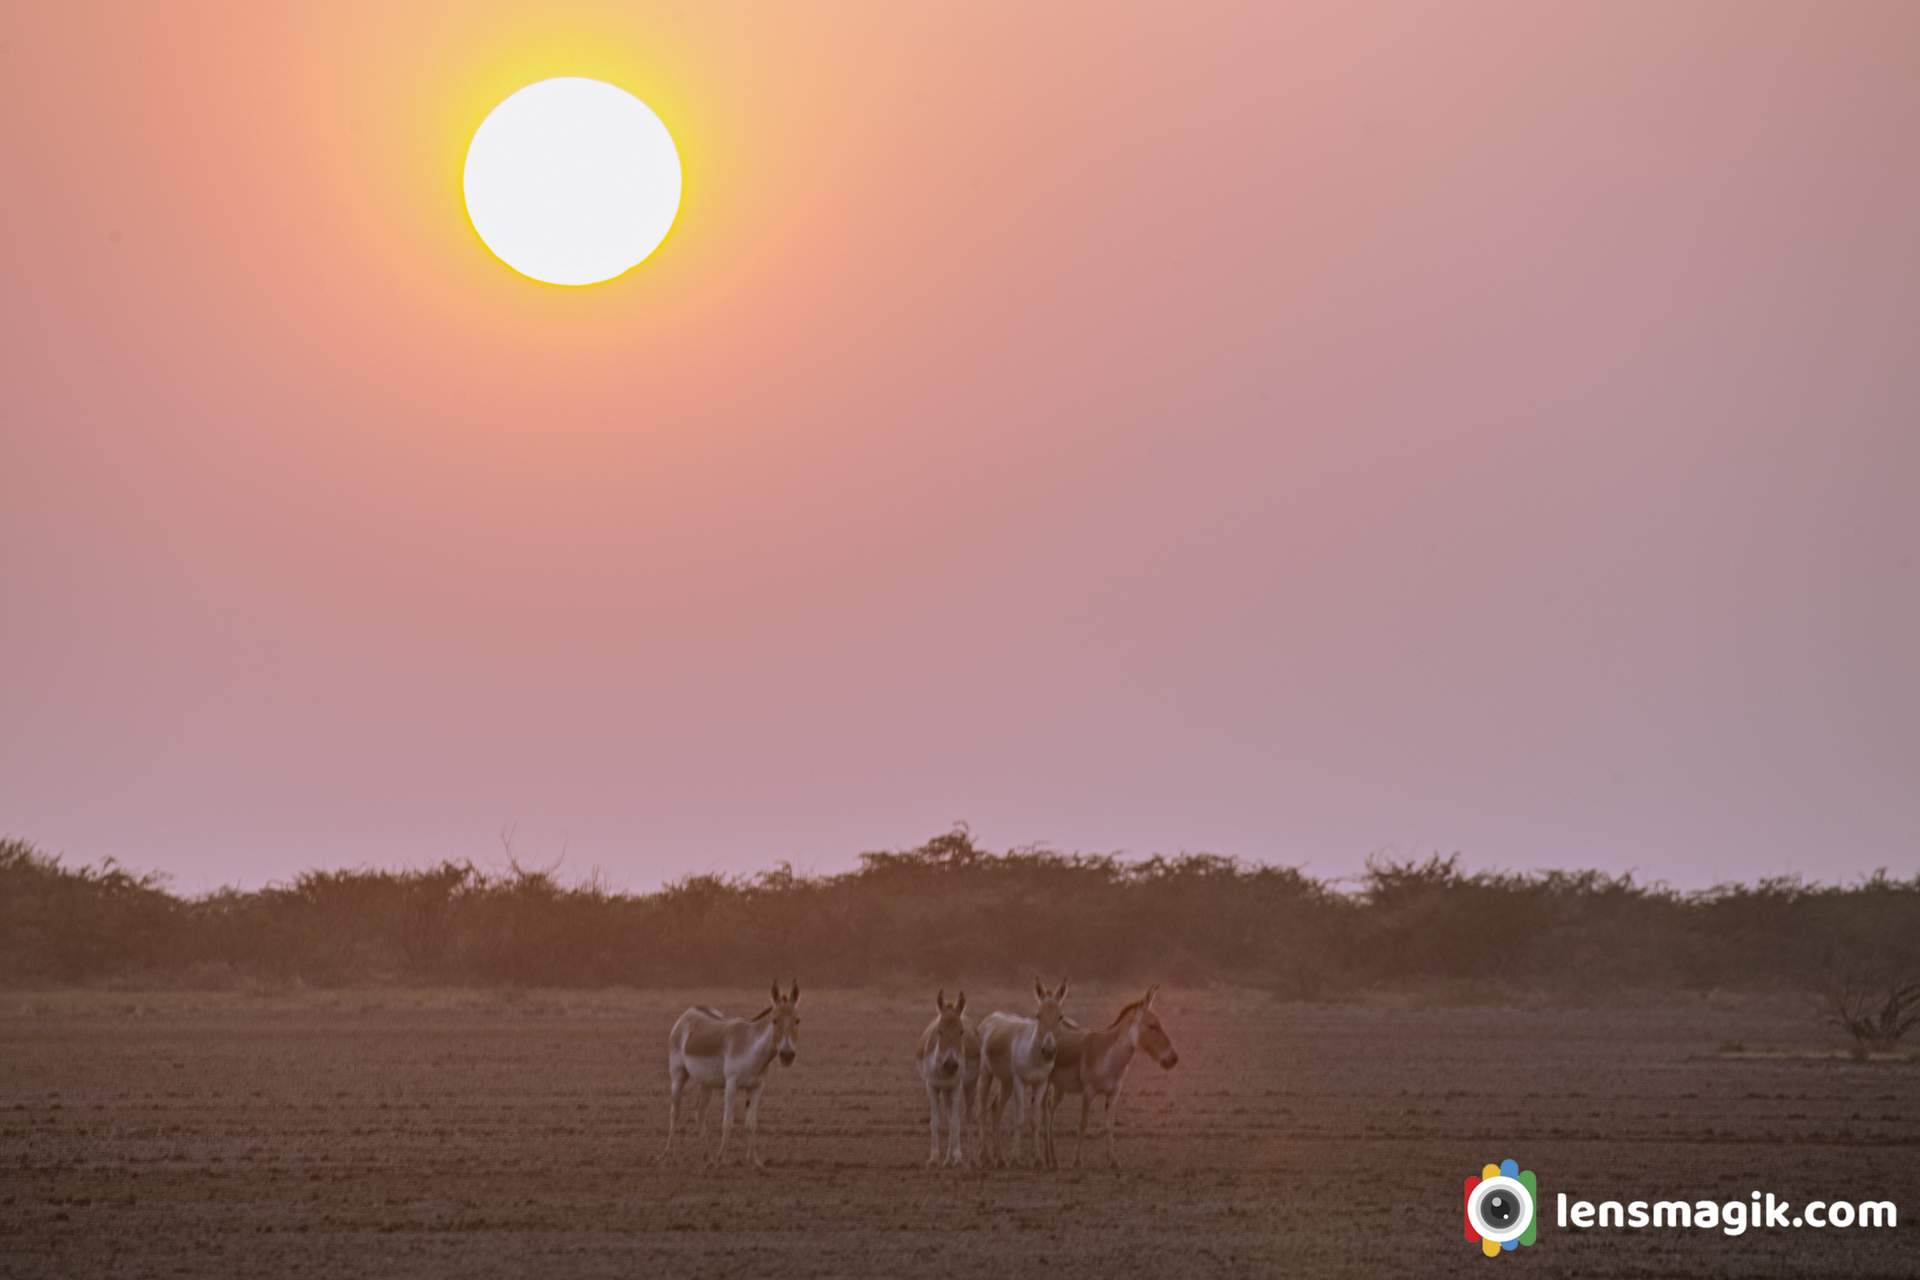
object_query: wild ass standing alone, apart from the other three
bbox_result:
[660,981,801,1169]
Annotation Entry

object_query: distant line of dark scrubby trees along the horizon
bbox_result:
[0,827,1920,998]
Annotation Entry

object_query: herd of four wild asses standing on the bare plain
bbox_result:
[660,979,1179,1169]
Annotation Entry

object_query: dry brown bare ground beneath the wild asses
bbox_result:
[0,983,1920,1280]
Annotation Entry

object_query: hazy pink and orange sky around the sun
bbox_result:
[0,0,1920,889]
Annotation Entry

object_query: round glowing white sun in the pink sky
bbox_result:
[467,77,680,284]
